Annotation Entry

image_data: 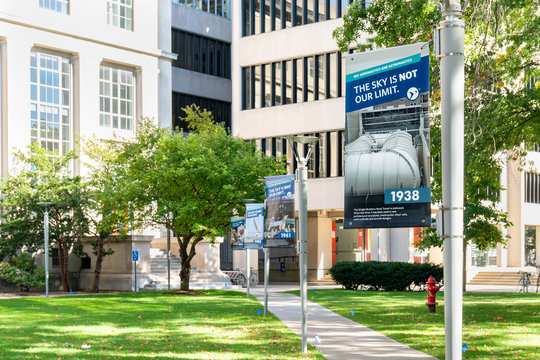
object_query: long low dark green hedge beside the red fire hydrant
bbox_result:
[330,261,443,291]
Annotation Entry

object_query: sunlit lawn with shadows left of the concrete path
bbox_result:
[0,291,324,360]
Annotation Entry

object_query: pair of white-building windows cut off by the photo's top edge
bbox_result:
[39,0,133,30]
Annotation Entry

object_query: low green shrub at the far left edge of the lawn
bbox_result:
[0,253,45,291]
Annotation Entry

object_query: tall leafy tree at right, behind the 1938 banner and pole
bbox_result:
[334,0,540,250]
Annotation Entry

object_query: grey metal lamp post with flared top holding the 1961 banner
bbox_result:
[285,136,319,354]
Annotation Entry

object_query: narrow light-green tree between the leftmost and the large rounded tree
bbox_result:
[82,138,129,293]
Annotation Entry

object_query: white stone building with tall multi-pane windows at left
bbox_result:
[0,0,175,289]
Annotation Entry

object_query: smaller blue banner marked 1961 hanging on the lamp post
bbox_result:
[264,175,296,248]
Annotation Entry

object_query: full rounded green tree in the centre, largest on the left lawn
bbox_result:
[124,105,283,290]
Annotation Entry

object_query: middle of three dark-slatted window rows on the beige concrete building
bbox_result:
[242,52,345,110]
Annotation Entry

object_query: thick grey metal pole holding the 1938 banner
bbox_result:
[437,0,465,360]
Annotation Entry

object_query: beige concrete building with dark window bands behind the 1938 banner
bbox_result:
[231,0,540,282]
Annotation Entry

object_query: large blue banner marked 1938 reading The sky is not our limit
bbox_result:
[344,43,431,228]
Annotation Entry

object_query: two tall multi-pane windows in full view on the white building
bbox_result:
[30,51,135,154]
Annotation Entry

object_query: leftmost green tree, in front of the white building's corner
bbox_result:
[0,143,88,291]
